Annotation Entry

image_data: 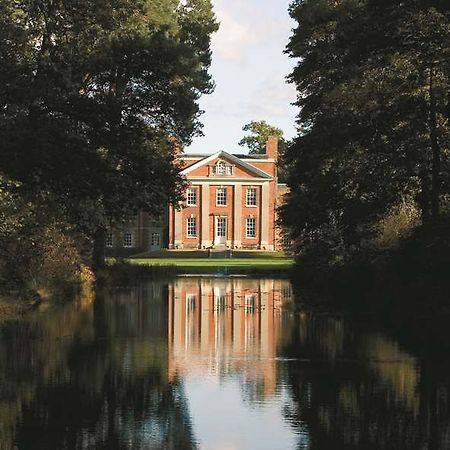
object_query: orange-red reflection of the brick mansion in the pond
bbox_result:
[169,278,291,395]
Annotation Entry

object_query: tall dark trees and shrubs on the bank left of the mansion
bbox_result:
[0,0,218,289]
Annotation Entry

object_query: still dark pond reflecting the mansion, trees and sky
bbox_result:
[0,277,450,450]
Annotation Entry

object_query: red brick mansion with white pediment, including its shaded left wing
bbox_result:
[107,138,286,251]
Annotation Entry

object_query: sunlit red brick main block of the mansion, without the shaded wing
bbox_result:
[168,138,284,250]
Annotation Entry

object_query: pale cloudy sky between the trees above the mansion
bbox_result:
[186,0,297,153]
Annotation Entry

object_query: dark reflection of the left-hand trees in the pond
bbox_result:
[0,286,195,450]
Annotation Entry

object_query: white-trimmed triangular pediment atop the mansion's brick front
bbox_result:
[181,151,272,179]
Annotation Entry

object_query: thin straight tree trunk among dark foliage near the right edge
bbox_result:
[429,68,441,222]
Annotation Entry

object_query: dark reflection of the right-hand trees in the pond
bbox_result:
[282,317,450,450]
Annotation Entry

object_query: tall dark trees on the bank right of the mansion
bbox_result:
[282,0,450,278]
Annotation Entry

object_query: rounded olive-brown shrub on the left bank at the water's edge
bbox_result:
[0,172,82,291]
